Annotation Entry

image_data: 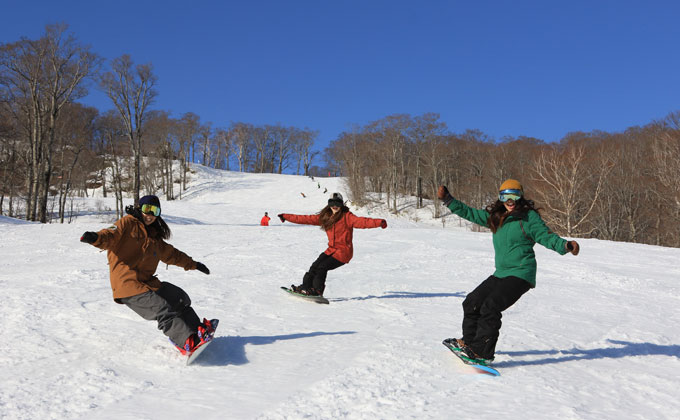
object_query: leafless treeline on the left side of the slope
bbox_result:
[0,24,318,223]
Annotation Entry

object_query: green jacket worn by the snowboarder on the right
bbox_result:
[448,198,567,287]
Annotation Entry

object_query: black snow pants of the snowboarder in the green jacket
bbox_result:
[463,276,531,359]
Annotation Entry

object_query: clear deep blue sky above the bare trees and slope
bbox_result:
[0,0,680,149]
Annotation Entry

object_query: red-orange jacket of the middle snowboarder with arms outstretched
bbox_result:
[283,212,384,264]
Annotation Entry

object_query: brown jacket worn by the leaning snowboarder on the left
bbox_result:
[92,215,196,303]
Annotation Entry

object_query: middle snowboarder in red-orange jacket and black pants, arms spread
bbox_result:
[279,193,387,296]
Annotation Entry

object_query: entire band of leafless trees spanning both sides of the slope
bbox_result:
[0,24,680,247]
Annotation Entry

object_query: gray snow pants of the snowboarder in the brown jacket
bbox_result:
[120,282,201,346]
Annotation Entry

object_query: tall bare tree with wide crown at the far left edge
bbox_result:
[0,24,100,223]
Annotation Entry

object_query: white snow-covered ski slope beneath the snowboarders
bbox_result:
[0,166,680,420]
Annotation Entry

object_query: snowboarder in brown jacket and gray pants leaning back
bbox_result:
[80,195,217,354]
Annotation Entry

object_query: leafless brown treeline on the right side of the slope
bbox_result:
[327,112,680,247]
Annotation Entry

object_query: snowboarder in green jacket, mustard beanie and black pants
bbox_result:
[437,179,579,364]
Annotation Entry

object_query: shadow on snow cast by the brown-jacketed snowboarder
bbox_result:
[189,331,356,366]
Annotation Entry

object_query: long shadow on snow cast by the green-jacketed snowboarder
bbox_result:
[493,340,680,369]
